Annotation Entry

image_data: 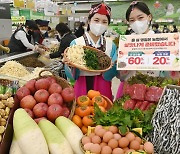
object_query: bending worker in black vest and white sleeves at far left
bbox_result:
[8,20,39,53]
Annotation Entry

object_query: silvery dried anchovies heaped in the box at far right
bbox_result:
[149,86,180,154]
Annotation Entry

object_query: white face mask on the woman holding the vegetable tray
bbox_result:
[90,23,108,36]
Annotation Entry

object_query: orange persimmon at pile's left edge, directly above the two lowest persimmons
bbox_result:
[75,106,91,117]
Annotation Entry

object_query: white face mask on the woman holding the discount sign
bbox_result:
[130,20,149,34]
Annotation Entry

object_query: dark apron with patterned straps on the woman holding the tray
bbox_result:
[83,34,106,92]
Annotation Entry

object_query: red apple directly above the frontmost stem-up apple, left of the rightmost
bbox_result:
[48,93,63,105]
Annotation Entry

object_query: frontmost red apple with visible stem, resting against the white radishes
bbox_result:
[47,104,62,122]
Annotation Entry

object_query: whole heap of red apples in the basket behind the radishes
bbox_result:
[16,76,75,122]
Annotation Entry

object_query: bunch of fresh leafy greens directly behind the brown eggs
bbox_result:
[94,96,155,136]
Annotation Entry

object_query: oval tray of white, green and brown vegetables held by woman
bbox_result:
[64,45,112,71]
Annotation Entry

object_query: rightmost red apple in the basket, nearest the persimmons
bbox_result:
[61,87,75,102]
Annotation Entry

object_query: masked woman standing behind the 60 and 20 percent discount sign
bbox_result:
[116,1,170,98]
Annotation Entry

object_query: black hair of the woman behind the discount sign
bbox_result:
[126,2,151,21]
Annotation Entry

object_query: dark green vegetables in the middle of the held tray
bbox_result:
[84,49,100,70]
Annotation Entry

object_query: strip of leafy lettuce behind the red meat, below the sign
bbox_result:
[127,72,178,88]
